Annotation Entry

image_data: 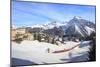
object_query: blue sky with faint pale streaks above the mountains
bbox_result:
[12,1,95,26]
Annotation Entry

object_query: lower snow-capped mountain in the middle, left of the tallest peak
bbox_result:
[43,21,67,36]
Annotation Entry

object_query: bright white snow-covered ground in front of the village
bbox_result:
[12,40,89,65]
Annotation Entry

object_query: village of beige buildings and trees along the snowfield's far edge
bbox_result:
[11,27,79,45]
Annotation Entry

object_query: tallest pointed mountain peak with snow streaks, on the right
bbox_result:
[65,17,95,37]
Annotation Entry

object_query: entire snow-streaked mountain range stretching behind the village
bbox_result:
[25,16,95,37]
